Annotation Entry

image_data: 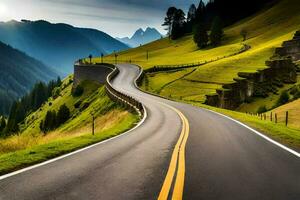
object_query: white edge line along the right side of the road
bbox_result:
[201,108,300,158]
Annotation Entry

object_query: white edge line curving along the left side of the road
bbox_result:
[0,65,147,180]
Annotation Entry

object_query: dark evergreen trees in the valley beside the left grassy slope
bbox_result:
[1,77,62,136]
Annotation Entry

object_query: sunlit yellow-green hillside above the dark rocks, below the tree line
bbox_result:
[94,0,300,108]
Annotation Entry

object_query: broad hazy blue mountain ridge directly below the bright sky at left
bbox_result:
[0,20,128,76]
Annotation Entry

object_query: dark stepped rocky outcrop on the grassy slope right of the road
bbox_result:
[206,32,300,110]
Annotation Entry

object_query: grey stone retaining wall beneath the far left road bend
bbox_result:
[73,64,113,87]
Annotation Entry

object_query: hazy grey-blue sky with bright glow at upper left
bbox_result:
[0,0,204,37]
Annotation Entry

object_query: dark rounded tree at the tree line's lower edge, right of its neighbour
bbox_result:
[209,16,224,46]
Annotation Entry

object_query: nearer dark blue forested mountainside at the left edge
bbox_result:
[0,42,58,115]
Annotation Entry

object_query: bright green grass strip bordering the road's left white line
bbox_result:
[0,114,138,175]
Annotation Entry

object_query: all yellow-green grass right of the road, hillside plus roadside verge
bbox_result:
[116,0,300,149]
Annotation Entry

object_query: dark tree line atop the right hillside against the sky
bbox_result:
[162,0,274,48]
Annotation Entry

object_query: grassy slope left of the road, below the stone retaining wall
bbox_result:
[0,76,138,174]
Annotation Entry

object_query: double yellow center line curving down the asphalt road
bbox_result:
[158,106,190,200]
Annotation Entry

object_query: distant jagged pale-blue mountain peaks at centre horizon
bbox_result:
[116,27,162,47]
